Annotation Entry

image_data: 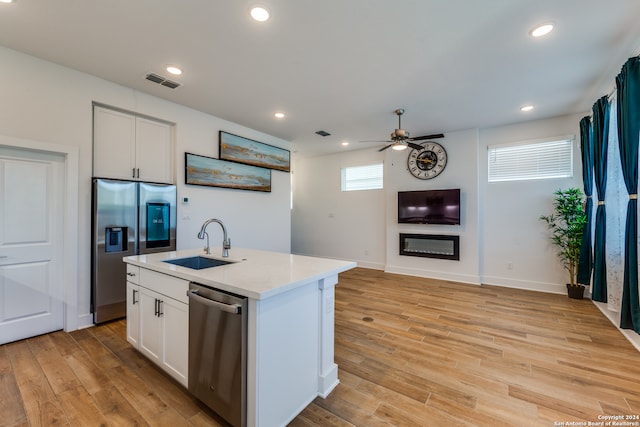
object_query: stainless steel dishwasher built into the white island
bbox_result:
[187,283,247,427]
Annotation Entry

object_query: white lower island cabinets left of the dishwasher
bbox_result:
[127,269,189,387]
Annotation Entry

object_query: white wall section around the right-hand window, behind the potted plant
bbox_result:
[478,114,584,293]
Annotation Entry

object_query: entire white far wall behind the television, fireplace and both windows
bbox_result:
[291,115,583,293]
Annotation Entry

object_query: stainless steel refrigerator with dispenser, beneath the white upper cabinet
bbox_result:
[91,178,176,323]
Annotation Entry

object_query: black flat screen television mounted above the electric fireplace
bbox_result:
[398,188,460,225]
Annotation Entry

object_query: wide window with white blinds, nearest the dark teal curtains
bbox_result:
[489,137,573,182]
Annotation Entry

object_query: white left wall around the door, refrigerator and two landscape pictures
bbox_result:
[0,47,291,325]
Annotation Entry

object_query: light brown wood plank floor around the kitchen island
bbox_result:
[0,269,640,427]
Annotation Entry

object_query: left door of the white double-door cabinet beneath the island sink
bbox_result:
[138,287,162,364]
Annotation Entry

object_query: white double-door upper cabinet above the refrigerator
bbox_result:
[93,106,174,184]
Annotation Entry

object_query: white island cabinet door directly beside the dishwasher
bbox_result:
[161,298,189,387]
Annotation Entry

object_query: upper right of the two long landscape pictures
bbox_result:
[218,130,291,172]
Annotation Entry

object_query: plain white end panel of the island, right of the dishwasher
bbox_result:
[247,281,322,426]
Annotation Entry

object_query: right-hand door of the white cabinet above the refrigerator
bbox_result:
[136,117,173,184]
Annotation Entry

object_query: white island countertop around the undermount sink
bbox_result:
[123,247,356,299]
